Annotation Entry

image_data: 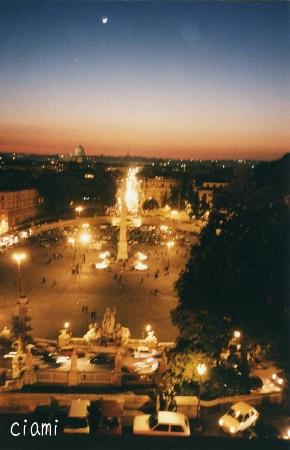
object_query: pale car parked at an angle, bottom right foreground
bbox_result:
[219,402,259,434]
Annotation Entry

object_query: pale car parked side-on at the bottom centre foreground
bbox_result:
[133,411,190,437]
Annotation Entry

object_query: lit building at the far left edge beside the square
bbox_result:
[0,189,43,230]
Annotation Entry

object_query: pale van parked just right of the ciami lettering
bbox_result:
[63,398,90,434]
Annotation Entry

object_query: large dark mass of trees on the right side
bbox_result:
[172,159,290,400]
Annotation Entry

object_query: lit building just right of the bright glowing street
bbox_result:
[141,177,180,207]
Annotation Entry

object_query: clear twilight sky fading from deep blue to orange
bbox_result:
[0,0,290,159]
